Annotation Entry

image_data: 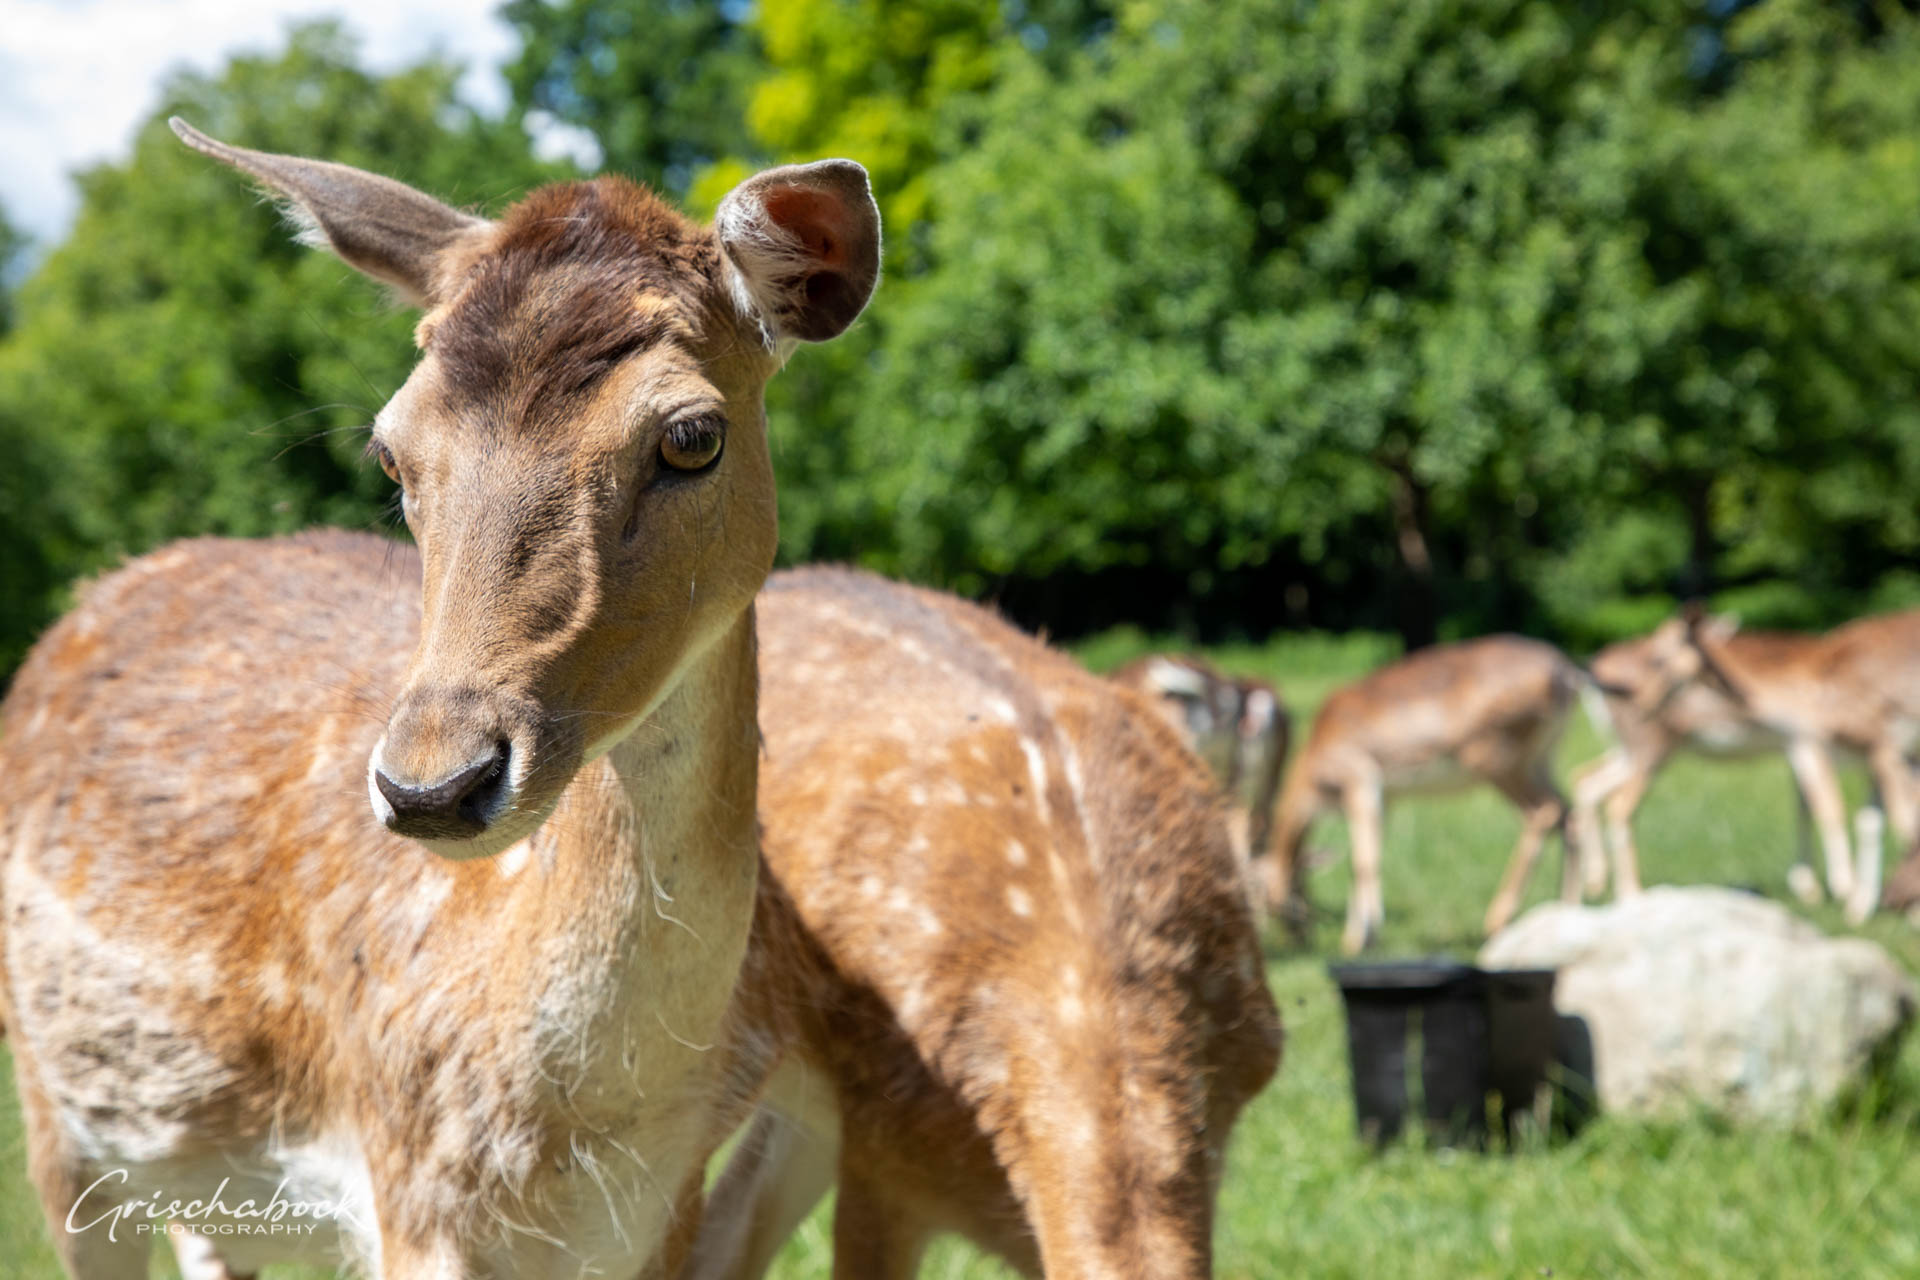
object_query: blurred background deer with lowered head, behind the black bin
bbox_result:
[1261,635,1586,954]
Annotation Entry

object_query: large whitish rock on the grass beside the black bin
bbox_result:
[1480,887,1916,1121]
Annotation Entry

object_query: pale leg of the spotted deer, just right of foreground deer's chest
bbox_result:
[682,1107,839,1280]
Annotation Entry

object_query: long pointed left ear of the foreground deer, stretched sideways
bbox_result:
[167,115,492,305]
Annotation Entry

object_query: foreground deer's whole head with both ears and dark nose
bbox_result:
[177,125,879,858]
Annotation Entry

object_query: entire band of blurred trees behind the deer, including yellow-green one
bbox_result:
[0,0,1920,666]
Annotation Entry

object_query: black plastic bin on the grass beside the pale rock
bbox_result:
[1331,960,1555,1146]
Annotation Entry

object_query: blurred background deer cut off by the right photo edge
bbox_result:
[1635,608,1920,923]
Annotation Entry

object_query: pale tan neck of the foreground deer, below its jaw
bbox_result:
[509,608,758,1107]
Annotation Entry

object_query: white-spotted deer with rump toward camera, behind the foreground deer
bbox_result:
[689,570,1279,1280]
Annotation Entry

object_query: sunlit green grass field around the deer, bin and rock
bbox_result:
[0,633,1920,1280]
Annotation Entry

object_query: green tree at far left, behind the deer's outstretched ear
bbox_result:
[0,23,557,670]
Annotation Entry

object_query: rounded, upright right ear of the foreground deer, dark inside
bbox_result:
[714,159,879,351]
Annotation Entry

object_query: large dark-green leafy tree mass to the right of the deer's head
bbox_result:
[764,0,1920,643]
